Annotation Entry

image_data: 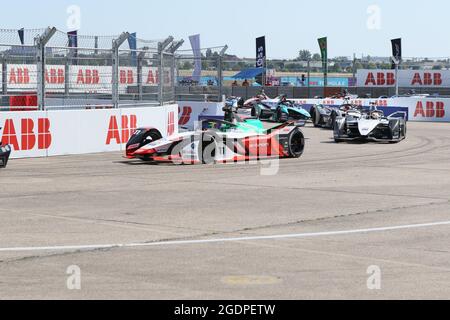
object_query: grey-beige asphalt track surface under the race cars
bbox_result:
[0,123,450,299]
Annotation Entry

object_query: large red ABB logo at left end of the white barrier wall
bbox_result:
[2,118,52,151]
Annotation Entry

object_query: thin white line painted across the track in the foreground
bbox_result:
[0,221,450,252]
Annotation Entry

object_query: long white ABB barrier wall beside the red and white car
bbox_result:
[0,105,178,158]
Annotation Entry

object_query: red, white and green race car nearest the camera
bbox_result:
[126,101,305,164]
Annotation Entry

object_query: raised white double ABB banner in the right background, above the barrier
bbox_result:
[356,69,450,88]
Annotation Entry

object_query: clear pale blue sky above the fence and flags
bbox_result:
[0,0,450,58]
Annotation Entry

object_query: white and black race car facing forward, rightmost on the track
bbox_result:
[334,106,407,143]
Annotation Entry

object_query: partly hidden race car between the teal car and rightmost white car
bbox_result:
[310,100,360,129]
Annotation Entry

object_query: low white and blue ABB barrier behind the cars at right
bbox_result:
[296,97,450,122]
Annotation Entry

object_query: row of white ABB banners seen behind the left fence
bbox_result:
[7,64,171,94]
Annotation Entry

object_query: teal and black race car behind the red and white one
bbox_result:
[246,96,311,122]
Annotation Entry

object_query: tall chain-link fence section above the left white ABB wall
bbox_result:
[0,28,176,110]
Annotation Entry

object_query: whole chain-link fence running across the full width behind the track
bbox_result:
[0,28,450,110]
